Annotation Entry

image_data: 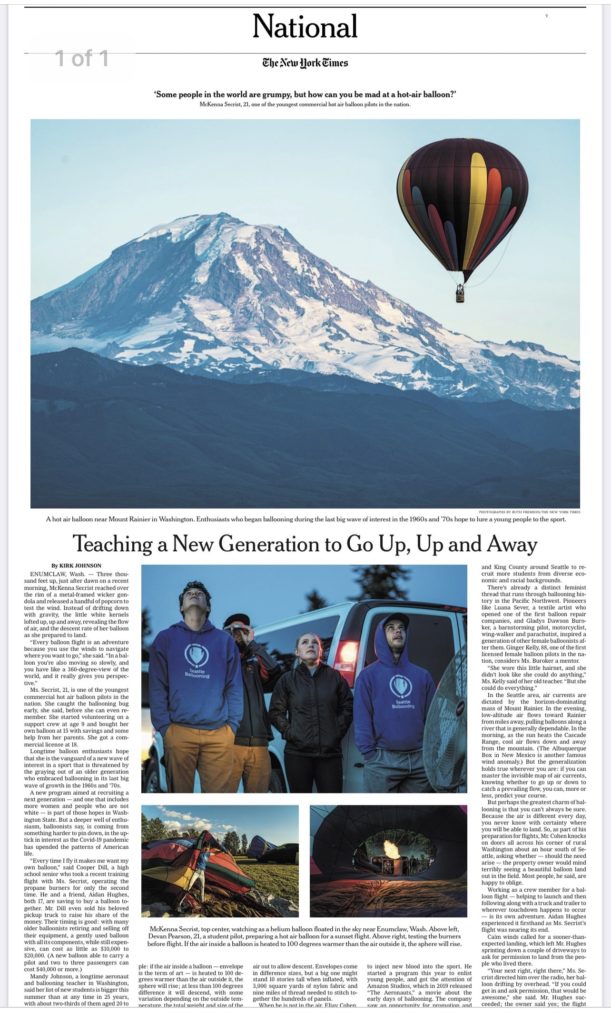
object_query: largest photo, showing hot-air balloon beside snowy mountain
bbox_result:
[32,120,579,509]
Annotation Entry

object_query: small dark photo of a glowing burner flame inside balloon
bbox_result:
[310,804,467,918]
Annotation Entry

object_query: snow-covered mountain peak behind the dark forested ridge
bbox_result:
[32,213,579,409]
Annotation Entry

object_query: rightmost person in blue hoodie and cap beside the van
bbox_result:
[354,612,435,793]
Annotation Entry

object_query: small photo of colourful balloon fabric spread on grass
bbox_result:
[141,804,299,918]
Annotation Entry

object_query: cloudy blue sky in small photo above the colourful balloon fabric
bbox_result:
[142,804,299,846]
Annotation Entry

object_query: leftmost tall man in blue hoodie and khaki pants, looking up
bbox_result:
[148,580,244,793]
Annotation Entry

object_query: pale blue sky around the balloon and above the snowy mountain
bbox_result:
[32,120,579,357]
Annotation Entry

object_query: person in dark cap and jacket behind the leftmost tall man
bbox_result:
[223,611,281,793]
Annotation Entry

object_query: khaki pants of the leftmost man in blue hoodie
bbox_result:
[164,722,235,793]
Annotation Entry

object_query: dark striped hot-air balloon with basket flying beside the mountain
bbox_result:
[397,138,528,302]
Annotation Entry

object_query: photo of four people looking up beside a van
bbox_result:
[141,565,468,794]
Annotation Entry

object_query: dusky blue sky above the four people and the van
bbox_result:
[142,565,467,635]
